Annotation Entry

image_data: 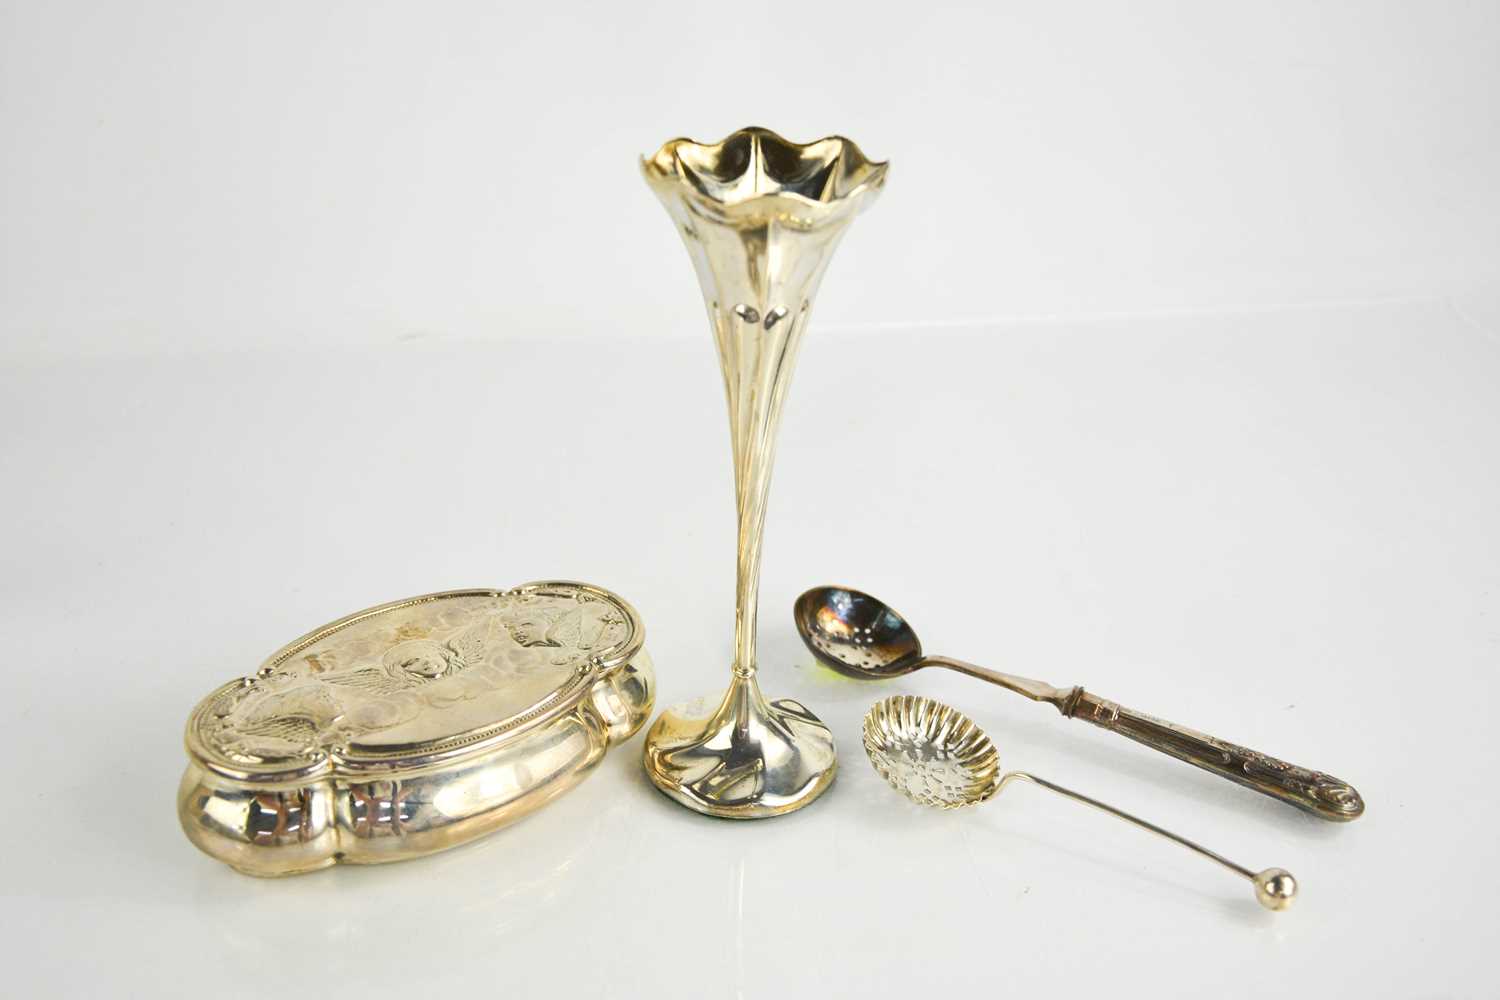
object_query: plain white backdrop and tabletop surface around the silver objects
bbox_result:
[0,3,1500,997]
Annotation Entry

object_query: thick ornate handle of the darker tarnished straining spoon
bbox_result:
[1058,688,1365,823]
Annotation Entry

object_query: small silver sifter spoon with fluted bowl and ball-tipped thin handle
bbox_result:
[864,694,1298,910]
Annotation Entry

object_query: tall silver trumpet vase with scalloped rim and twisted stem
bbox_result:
[642,129,885,819]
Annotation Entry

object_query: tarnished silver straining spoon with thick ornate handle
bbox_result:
[792,586,1365,823]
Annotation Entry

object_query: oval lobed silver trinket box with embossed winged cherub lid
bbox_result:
[177,580,656,876]
